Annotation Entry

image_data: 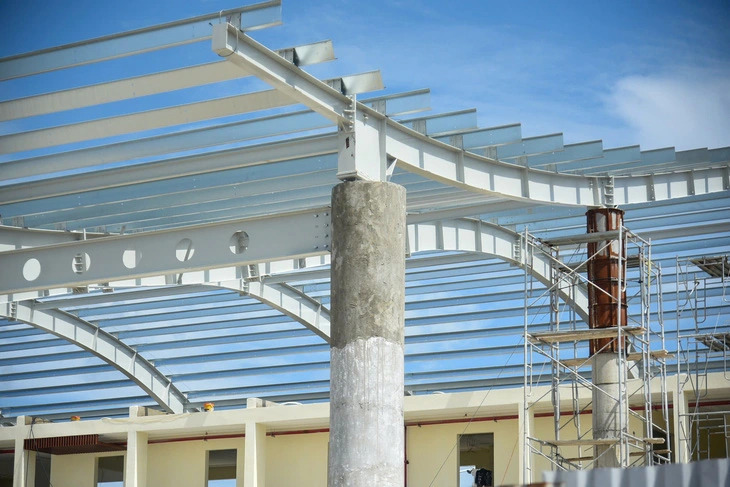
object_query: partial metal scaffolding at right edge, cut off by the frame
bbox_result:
[675,255,730,461]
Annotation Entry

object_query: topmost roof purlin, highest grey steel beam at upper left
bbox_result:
[0,0,281,80]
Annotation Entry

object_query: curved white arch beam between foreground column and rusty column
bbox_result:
[408,219,588,321]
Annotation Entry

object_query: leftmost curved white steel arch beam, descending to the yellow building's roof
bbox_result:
[0,302,188,413]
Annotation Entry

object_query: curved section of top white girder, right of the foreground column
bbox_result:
[376,105,730,206]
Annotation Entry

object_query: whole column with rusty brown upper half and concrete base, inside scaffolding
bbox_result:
[586,208,628,467]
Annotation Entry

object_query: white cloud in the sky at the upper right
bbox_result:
[608,70,730,150]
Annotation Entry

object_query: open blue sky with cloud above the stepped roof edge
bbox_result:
[0,0,730,150]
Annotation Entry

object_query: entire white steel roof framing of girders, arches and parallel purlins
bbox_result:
[0,1,730,418]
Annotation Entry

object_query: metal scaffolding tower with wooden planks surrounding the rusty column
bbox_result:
[521,227,672,482]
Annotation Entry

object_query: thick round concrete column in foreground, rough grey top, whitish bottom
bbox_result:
[327,181,406,487]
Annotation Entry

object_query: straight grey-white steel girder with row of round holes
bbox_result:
[0,209,330,294]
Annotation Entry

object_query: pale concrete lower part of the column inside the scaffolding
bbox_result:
[591,352,629,467]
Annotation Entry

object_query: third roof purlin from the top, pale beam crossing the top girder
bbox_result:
[0,72,382,154]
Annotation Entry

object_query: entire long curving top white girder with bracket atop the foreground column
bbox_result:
[208,20,728,207]
